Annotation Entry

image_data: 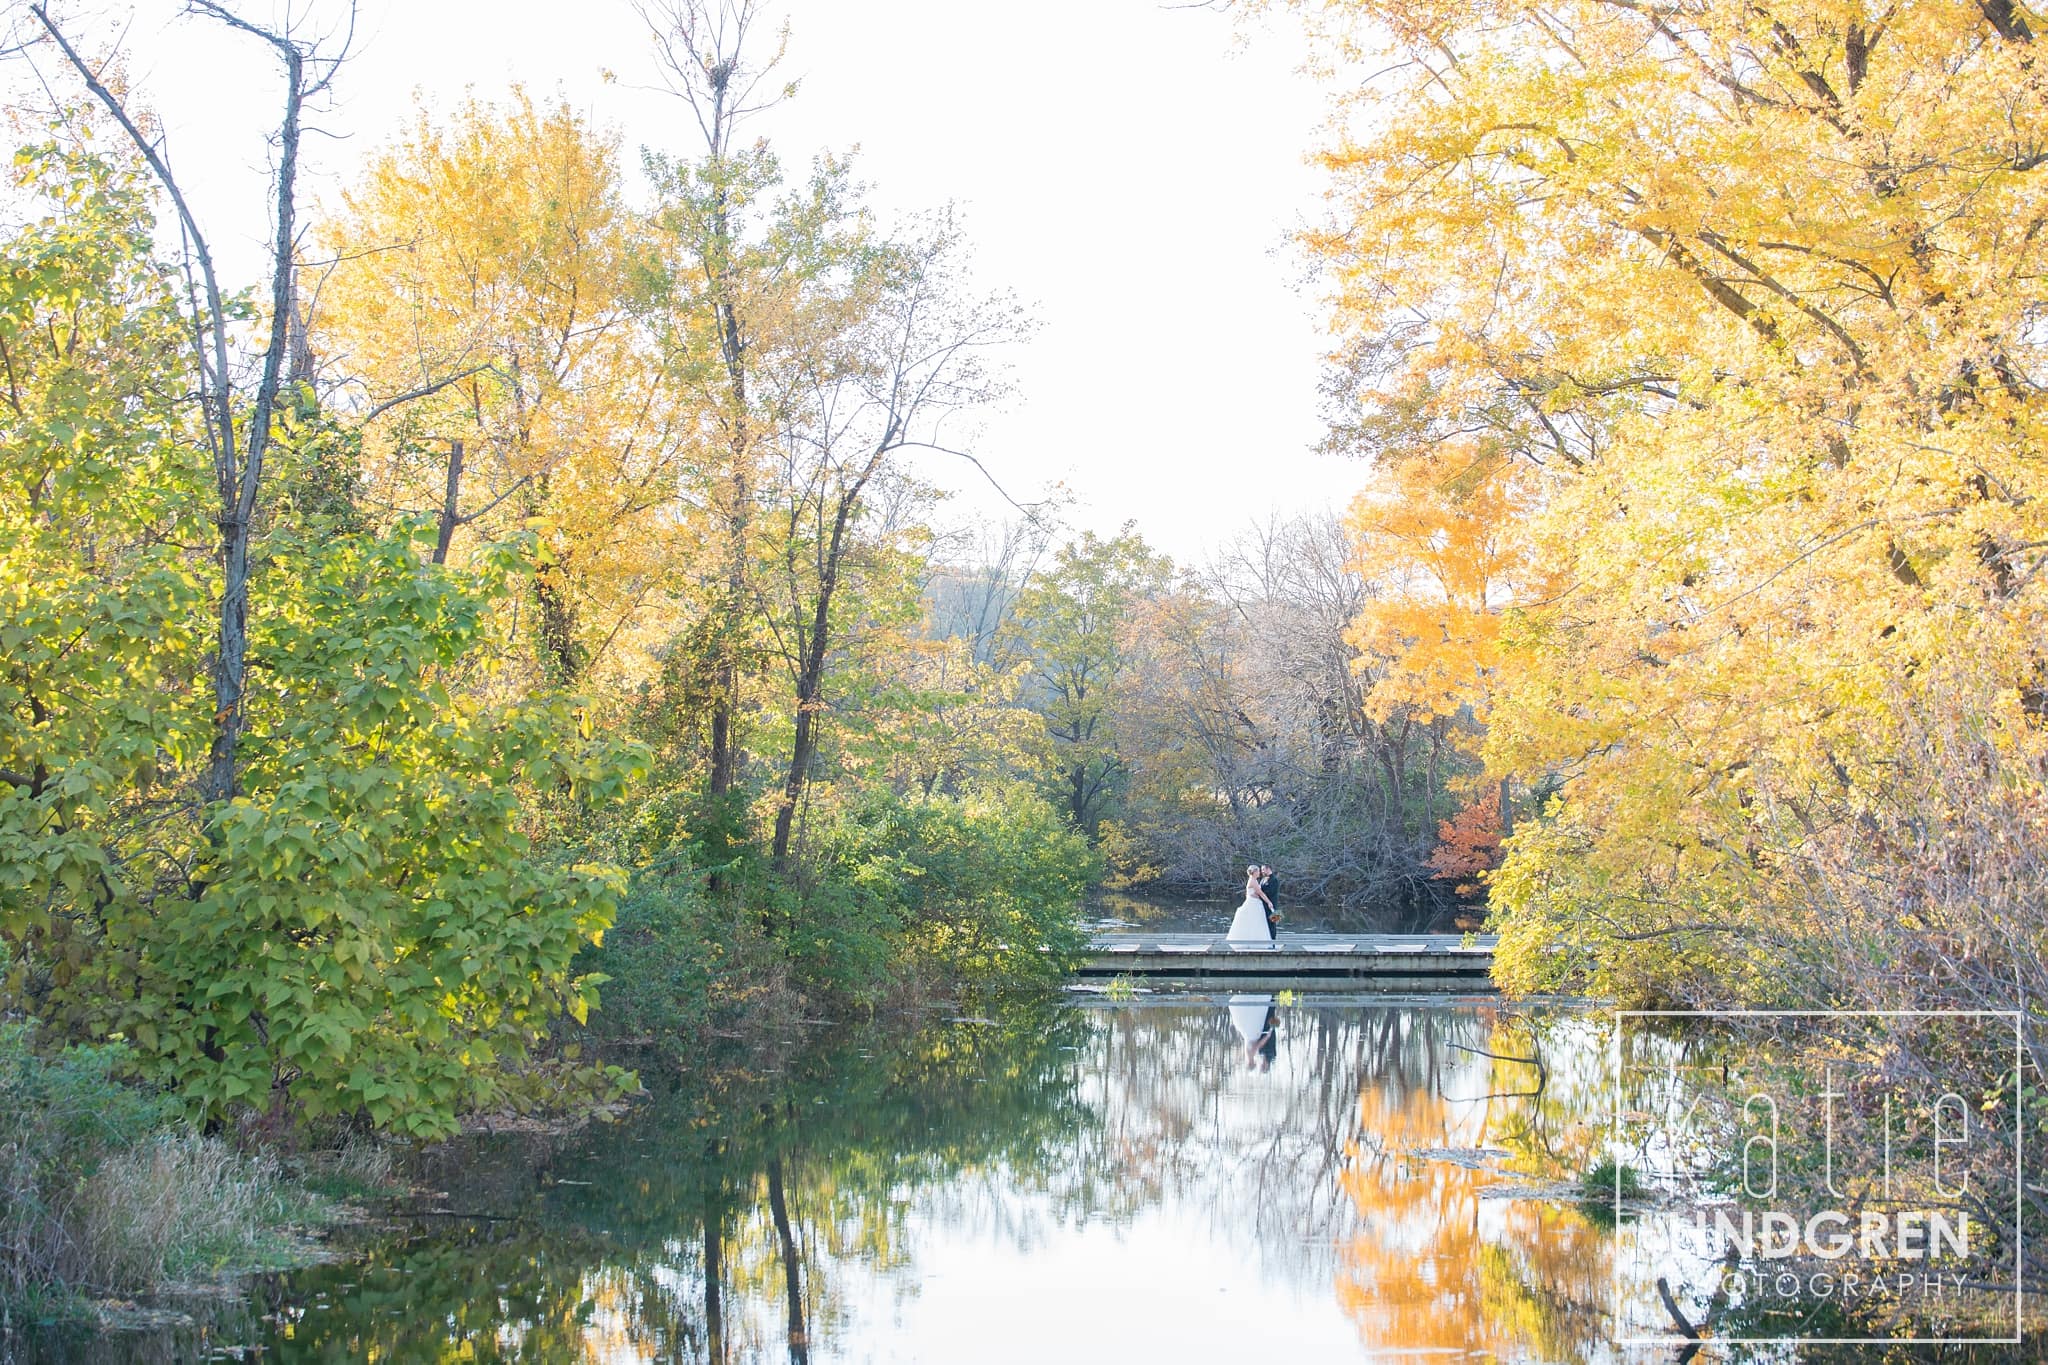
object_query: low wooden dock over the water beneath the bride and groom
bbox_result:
[1081,931,1495,990]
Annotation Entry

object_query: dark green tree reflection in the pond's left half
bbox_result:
[165,1009,1092,1365]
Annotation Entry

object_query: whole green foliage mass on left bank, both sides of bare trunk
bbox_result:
[0,147,637,1136]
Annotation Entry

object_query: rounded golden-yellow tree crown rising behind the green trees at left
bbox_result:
[303,92,690,684]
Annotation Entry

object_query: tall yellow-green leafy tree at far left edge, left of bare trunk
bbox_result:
[0,145,217,1031]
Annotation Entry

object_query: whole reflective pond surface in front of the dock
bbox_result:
[32,995,1728,1365]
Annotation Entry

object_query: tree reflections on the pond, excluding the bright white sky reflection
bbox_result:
[159,1003,1654,1363]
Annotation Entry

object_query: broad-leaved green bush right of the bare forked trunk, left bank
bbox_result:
[129,519,629,1134]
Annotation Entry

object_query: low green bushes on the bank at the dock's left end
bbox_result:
[578,784,1100,1039]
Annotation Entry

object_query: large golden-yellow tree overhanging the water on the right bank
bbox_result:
[1303,0,2048,997]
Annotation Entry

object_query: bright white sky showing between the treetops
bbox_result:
[16,0,1364,561]
